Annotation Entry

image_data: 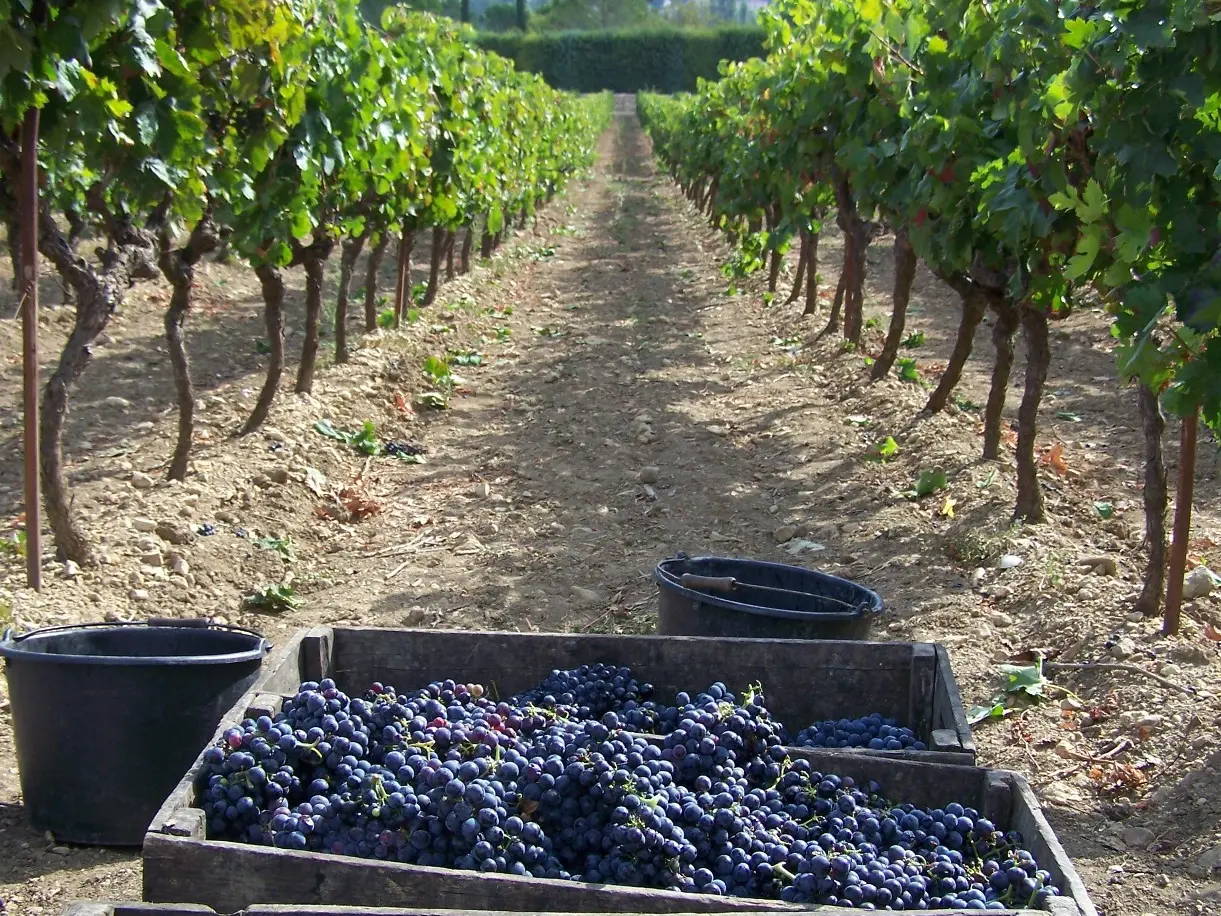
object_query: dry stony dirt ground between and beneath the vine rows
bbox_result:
[0,100,1221,916]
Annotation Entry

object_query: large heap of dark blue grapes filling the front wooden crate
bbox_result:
[200,664,1059,910]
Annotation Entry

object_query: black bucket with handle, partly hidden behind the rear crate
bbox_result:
[653,553,882,639]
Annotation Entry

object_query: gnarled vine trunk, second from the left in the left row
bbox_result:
[158,216,220,480]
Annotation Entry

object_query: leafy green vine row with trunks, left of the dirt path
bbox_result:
[0,0,612,564]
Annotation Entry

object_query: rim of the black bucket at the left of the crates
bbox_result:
[0,618,271,668]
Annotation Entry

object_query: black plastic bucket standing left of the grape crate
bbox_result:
[0,619,271,846]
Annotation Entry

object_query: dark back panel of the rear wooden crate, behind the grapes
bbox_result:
[332,629,912,732]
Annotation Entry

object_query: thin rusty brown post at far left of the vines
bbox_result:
[20,107,43,591]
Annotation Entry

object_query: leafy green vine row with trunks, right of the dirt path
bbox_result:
[639,0,1221,625]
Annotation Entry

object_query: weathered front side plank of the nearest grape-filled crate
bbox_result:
[143,834,795,914]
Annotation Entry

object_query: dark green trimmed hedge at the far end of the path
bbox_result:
[476,26,763,93]
